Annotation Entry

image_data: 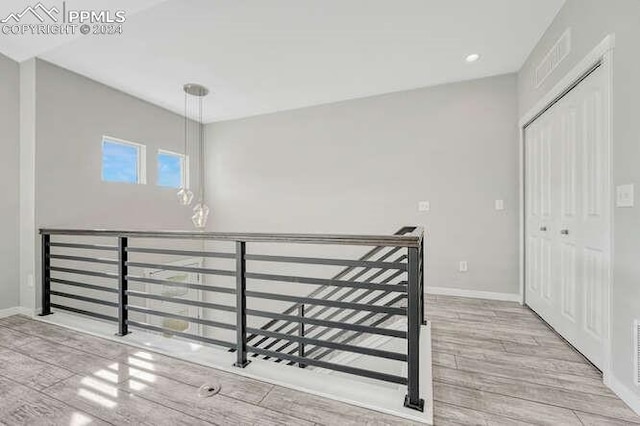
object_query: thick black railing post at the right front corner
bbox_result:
[404,247,424,411]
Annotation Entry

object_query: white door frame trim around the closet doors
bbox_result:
[518,34,615,376]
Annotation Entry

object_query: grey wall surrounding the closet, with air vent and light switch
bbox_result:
[518,0,640,410]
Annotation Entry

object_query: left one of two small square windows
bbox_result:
[102,136,147,184]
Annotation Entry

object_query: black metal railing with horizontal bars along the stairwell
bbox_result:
[40,227,424,411]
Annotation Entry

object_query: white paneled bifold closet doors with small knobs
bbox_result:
[525,65,611,368]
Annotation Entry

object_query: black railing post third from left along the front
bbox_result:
[233,241,251,368]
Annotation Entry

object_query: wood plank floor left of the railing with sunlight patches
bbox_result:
[0,316,416,426]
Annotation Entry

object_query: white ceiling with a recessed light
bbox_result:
[0,0,564,122]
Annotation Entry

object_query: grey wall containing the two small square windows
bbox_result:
[22,60,200,308]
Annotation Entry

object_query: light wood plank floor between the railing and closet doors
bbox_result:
[426,296,640,426]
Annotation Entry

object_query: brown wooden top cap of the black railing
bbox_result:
[40,227,423,247]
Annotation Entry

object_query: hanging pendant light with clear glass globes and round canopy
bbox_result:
[178,83,209,229]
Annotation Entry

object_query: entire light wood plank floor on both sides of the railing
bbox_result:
[0,296,640,426]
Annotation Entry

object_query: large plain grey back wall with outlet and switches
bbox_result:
[207,75,519,294]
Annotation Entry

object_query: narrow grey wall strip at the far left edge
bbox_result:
[0,54,20,309]
